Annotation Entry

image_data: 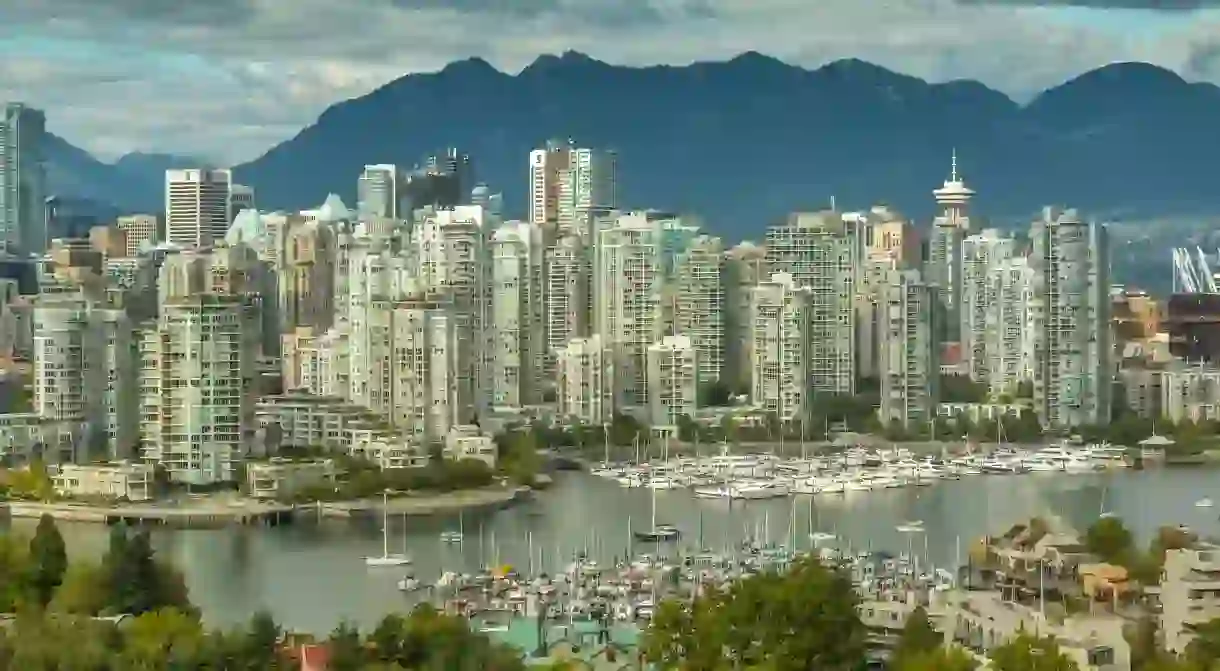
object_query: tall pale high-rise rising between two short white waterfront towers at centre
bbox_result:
[593,212,664,412]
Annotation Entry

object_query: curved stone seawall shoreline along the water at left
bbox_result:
[0,487,531,528]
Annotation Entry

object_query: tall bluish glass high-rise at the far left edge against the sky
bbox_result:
[0,102,50,256]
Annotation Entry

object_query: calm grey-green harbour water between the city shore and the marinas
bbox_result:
[13,468,1220,633]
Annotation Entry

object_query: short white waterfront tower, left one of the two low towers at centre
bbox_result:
[555,336,614,426]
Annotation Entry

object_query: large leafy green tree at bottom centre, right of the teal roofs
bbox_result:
[643,559,866,671]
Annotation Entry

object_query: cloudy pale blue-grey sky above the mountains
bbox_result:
[0,0,1220,162]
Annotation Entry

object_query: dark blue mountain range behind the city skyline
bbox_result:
[48,52,1220,235]
